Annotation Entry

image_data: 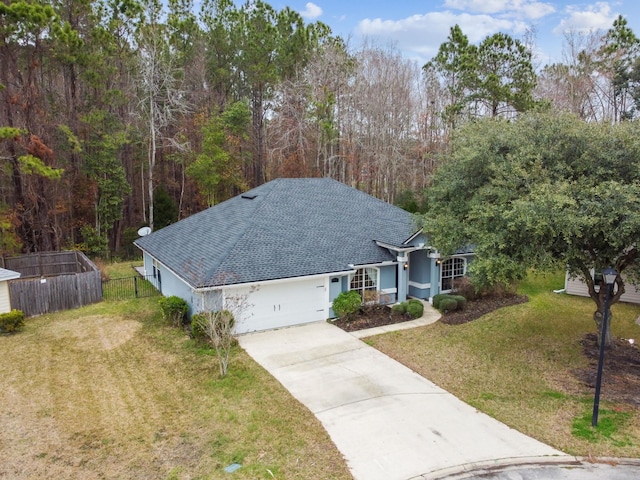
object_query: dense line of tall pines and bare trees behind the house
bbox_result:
[0,0,640,254]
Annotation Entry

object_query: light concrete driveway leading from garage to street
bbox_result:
[239,322,573,480]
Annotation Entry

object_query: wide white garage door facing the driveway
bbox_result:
[227,278,327,333]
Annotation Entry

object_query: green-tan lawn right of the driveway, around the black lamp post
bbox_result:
[367,274,640,457]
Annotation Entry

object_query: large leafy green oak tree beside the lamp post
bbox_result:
[422,113,640,346]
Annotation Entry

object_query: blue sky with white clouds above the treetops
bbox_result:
[269,0,640,65]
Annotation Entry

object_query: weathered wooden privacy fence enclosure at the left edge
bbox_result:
[2,251,102,317]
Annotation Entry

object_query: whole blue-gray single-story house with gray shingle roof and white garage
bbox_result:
[135,178,471,333]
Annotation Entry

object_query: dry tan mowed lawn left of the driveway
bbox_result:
[0,299,351,479]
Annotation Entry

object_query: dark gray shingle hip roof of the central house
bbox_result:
[135,178,417,287]
